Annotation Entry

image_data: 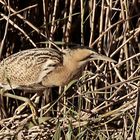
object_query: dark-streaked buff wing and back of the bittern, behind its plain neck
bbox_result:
[0,48,63,89]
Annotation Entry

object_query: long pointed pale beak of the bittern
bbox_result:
[90,53,116,63]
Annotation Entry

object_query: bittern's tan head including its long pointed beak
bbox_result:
[66,48,115,64]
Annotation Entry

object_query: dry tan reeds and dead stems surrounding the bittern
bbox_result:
[0,0,140,140]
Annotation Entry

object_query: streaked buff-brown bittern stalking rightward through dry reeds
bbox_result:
[0,47,115,115]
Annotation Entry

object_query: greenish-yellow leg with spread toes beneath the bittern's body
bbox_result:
[0,89,37,116]
